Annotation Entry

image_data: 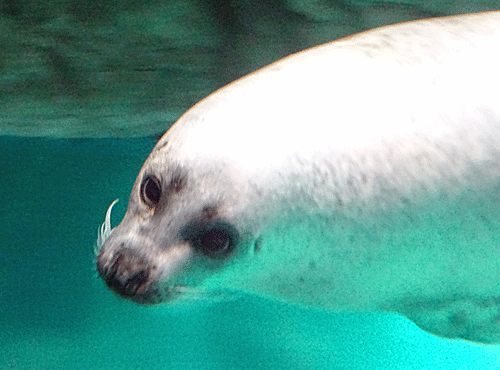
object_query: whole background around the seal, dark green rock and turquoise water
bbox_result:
[0,0,500,370]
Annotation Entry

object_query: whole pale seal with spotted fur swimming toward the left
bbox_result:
[97,12,500,342]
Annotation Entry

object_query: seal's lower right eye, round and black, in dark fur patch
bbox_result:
[194,221,237,258]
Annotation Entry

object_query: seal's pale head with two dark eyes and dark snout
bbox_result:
[97,137,268,304]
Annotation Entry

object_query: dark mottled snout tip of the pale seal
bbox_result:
[97,248,158,303]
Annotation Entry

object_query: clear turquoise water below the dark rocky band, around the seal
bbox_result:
[0,137,500,370]
